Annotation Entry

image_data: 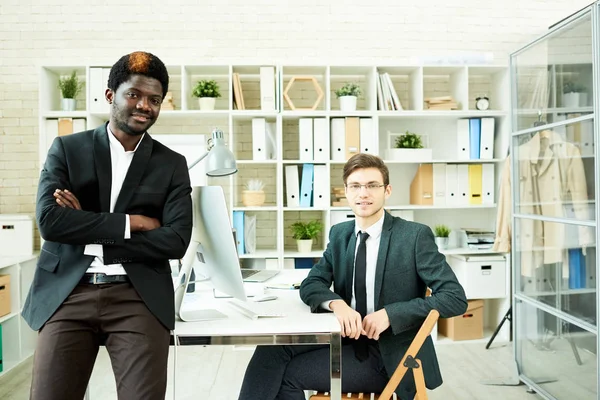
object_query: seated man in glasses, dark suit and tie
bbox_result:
[239,153,467,400]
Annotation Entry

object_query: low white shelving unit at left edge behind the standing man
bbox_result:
[0,255,37,377]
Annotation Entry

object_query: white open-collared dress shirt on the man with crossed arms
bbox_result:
[83,125,145,275]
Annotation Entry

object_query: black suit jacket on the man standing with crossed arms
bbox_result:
[23,125,192,330]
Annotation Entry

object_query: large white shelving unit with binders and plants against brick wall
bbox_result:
[39,64,510,340]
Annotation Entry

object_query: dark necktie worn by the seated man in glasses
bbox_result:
[354,232,369,361]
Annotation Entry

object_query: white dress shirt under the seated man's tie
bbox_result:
[321,213,385,314]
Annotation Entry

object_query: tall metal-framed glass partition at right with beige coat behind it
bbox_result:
[504,2,600,400]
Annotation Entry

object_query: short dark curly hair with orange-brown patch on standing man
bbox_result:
[108,51,169,100]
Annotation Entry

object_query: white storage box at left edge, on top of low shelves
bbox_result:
[0,214,33,257]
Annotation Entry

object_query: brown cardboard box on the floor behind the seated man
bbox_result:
[438,300,483,340]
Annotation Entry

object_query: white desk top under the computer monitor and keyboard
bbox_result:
[175,270,340,337]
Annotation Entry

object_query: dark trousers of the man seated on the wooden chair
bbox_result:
[239,344,388,400]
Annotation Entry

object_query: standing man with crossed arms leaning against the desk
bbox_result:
[23,52,192,400]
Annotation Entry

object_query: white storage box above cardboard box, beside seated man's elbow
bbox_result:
[448,254,507,300]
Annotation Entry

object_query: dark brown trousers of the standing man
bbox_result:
[31,283,169,400]
